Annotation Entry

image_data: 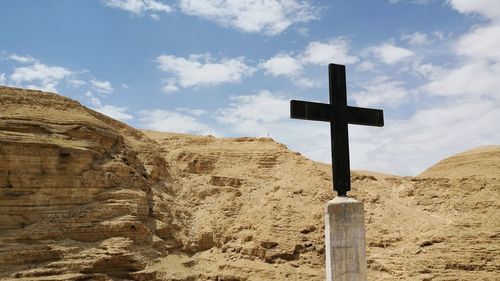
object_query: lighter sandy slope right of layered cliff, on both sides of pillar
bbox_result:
[141,131,500,280]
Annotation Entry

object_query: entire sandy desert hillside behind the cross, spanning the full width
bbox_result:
[0,87,500,281]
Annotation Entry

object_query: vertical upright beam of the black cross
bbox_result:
[328,64,351,196]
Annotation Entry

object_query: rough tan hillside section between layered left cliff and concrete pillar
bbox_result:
[141,131,332,280]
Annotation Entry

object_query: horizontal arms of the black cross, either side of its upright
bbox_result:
[290,100,384,127]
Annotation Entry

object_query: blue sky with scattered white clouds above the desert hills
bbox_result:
[0,0,500,175]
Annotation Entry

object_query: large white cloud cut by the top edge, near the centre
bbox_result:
[179,0,317,36]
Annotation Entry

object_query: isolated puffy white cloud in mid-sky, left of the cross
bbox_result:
[156,54,255,92]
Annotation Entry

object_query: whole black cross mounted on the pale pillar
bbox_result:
[290,64,384,196]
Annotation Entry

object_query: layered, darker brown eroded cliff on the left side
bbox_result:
[0,87,169,279]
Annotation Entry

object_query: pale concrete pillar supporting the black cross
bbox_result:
[325,197,366,281]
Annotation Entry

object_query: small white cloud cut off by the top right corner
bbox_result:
[448,0,500,21]
